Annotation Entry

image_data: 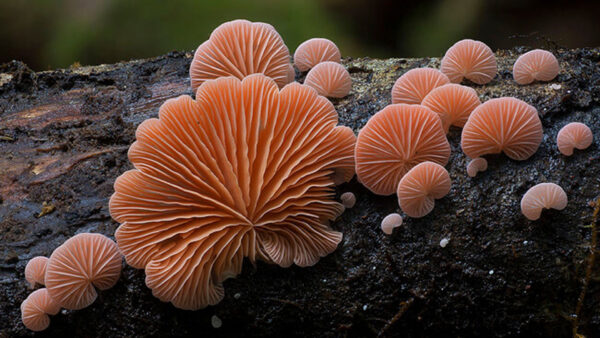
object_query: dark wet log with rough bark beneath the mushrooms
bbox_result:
[0,49,600,337]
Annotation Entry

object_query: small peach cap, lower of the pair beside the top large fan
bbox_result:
[304,61,352,98]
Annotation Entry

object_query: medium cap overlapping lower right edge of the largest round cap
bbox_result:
[397,162,452,218]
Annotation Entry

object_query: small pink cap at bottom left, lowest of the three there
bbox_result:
[21,288,60,331]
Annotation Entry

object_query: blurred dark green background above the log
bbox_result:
[0,0,600,70]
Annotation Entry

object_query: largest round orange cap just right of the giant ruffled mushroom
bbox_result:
[354,104,450,195]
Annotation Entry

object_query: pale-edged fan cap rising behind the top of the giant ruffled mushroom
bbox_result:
[190,20,290,91]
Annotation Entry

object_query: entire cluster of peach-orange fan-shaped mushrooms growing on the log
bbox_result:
[22,20,592,330]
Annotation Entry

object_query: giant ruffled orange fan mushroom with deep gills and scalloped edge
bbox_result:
[109,74,356,310]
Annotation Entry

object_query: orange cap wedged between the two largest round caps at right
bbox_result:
[421,83,481,133]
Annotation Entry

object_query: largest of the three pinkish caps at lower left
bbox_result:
[46,233,122,310]
